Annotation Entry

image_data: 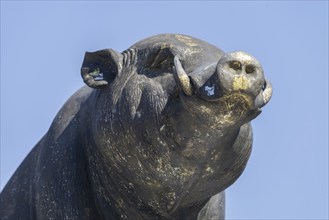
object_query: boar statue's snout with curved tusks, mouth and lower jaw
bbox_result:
[174,51,272,127]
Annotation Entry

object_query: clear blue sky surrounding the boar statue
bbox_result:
[1,1,328,219]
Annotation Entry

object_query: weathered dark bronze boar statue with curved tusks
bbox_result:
[1,34,272,220]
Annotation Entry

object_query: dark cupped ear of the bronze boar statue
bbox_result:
[81,49,122,89]
